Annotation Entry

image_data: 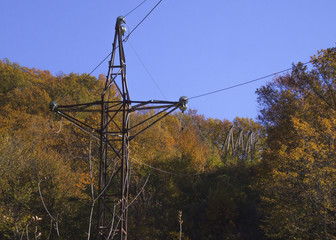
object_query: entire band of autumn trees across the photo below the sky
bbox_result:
[0,46,336,240]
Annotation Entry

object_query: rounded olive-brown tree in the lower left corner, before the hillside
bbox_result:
[0,135,90,239]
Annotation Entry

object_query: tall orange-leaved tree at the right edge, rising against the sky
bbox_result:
[257,48,336,239]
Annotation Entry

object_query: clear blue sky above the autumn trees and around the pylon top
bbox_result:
[0,0,336,120]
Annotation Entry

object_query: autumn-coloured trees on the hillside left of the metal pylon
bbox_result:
[0,60,100,239]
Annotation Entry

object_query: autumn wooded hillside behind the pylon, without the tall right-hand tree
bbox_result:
[0,60,268,240]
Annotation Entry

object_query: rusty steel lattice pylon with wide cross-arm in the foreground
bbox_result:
[50,17,188,240]
